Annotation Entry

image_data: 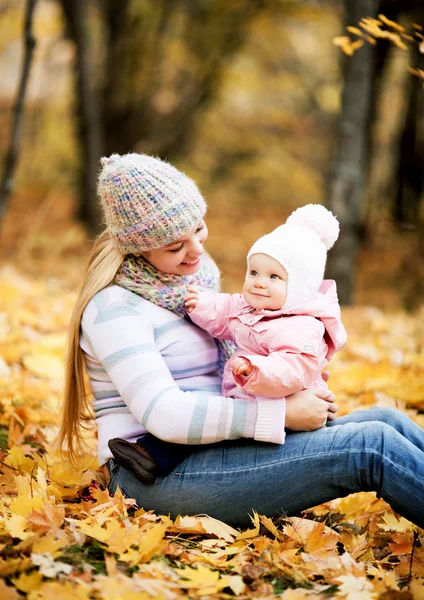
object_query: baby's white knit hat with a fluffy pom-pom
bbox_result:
[247,204,339,312]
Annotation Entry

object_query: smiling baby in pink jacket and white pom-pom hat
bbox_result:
[185,204,346,398]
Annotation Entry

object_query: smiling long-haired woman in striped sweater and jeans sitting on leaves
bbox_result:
[60,154,424,527]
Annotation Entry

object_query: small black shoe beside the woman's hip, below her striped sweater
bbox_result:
[108,438,160,485]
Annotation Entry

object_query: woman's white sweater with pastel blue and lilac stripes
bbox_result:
[80,285,285,465]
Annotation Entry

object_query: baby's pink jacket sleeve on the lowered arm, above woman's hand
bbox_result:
[234,317,324,398]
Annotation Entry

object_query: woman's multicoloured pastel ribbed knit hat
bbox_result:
[97,154,206,254]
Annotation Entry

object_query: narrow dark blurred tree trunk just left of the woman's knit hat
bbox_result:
[61,0,102,234]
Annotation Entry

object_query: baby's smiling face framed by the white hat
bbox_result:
[243,254,288,310]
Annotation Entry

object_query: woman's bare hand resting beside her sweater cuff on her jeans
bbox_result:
[285,389,339,431]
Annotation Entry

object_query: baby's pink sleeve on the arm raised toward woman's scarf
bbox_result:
[189,292,242,340]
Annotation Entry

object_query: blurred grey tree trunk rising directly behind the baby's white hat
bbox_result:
[327,0,379,304]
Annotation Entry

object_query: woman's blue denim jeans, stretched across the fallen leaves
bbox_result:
[108,408,424,527]
